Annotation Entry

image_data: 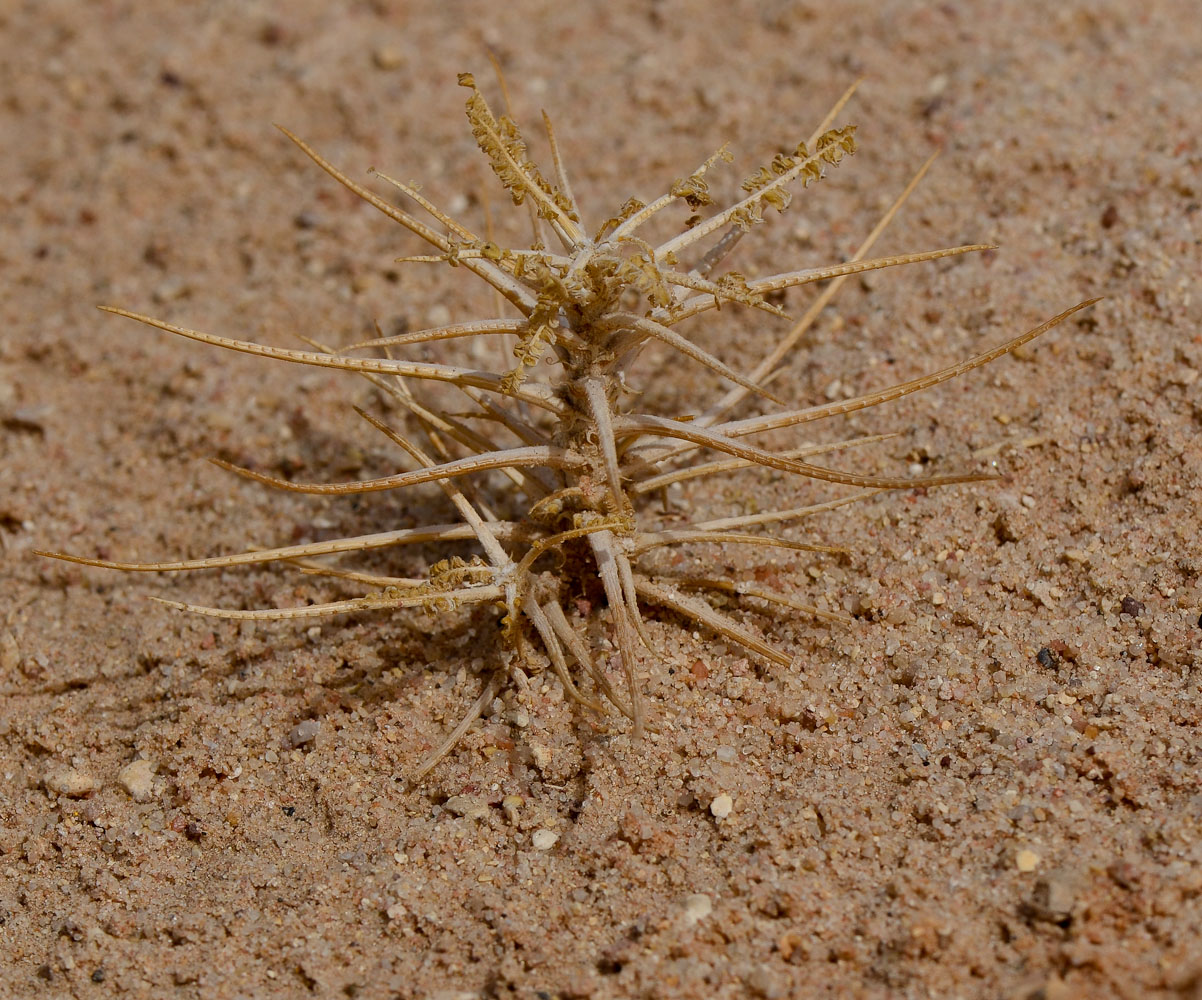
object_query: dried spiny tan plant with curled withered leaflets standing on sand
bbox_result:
[42,73,1090,779]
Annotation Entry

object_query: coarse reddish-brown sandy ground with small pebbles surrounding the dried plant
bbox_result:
[0,0,1202,1000]
